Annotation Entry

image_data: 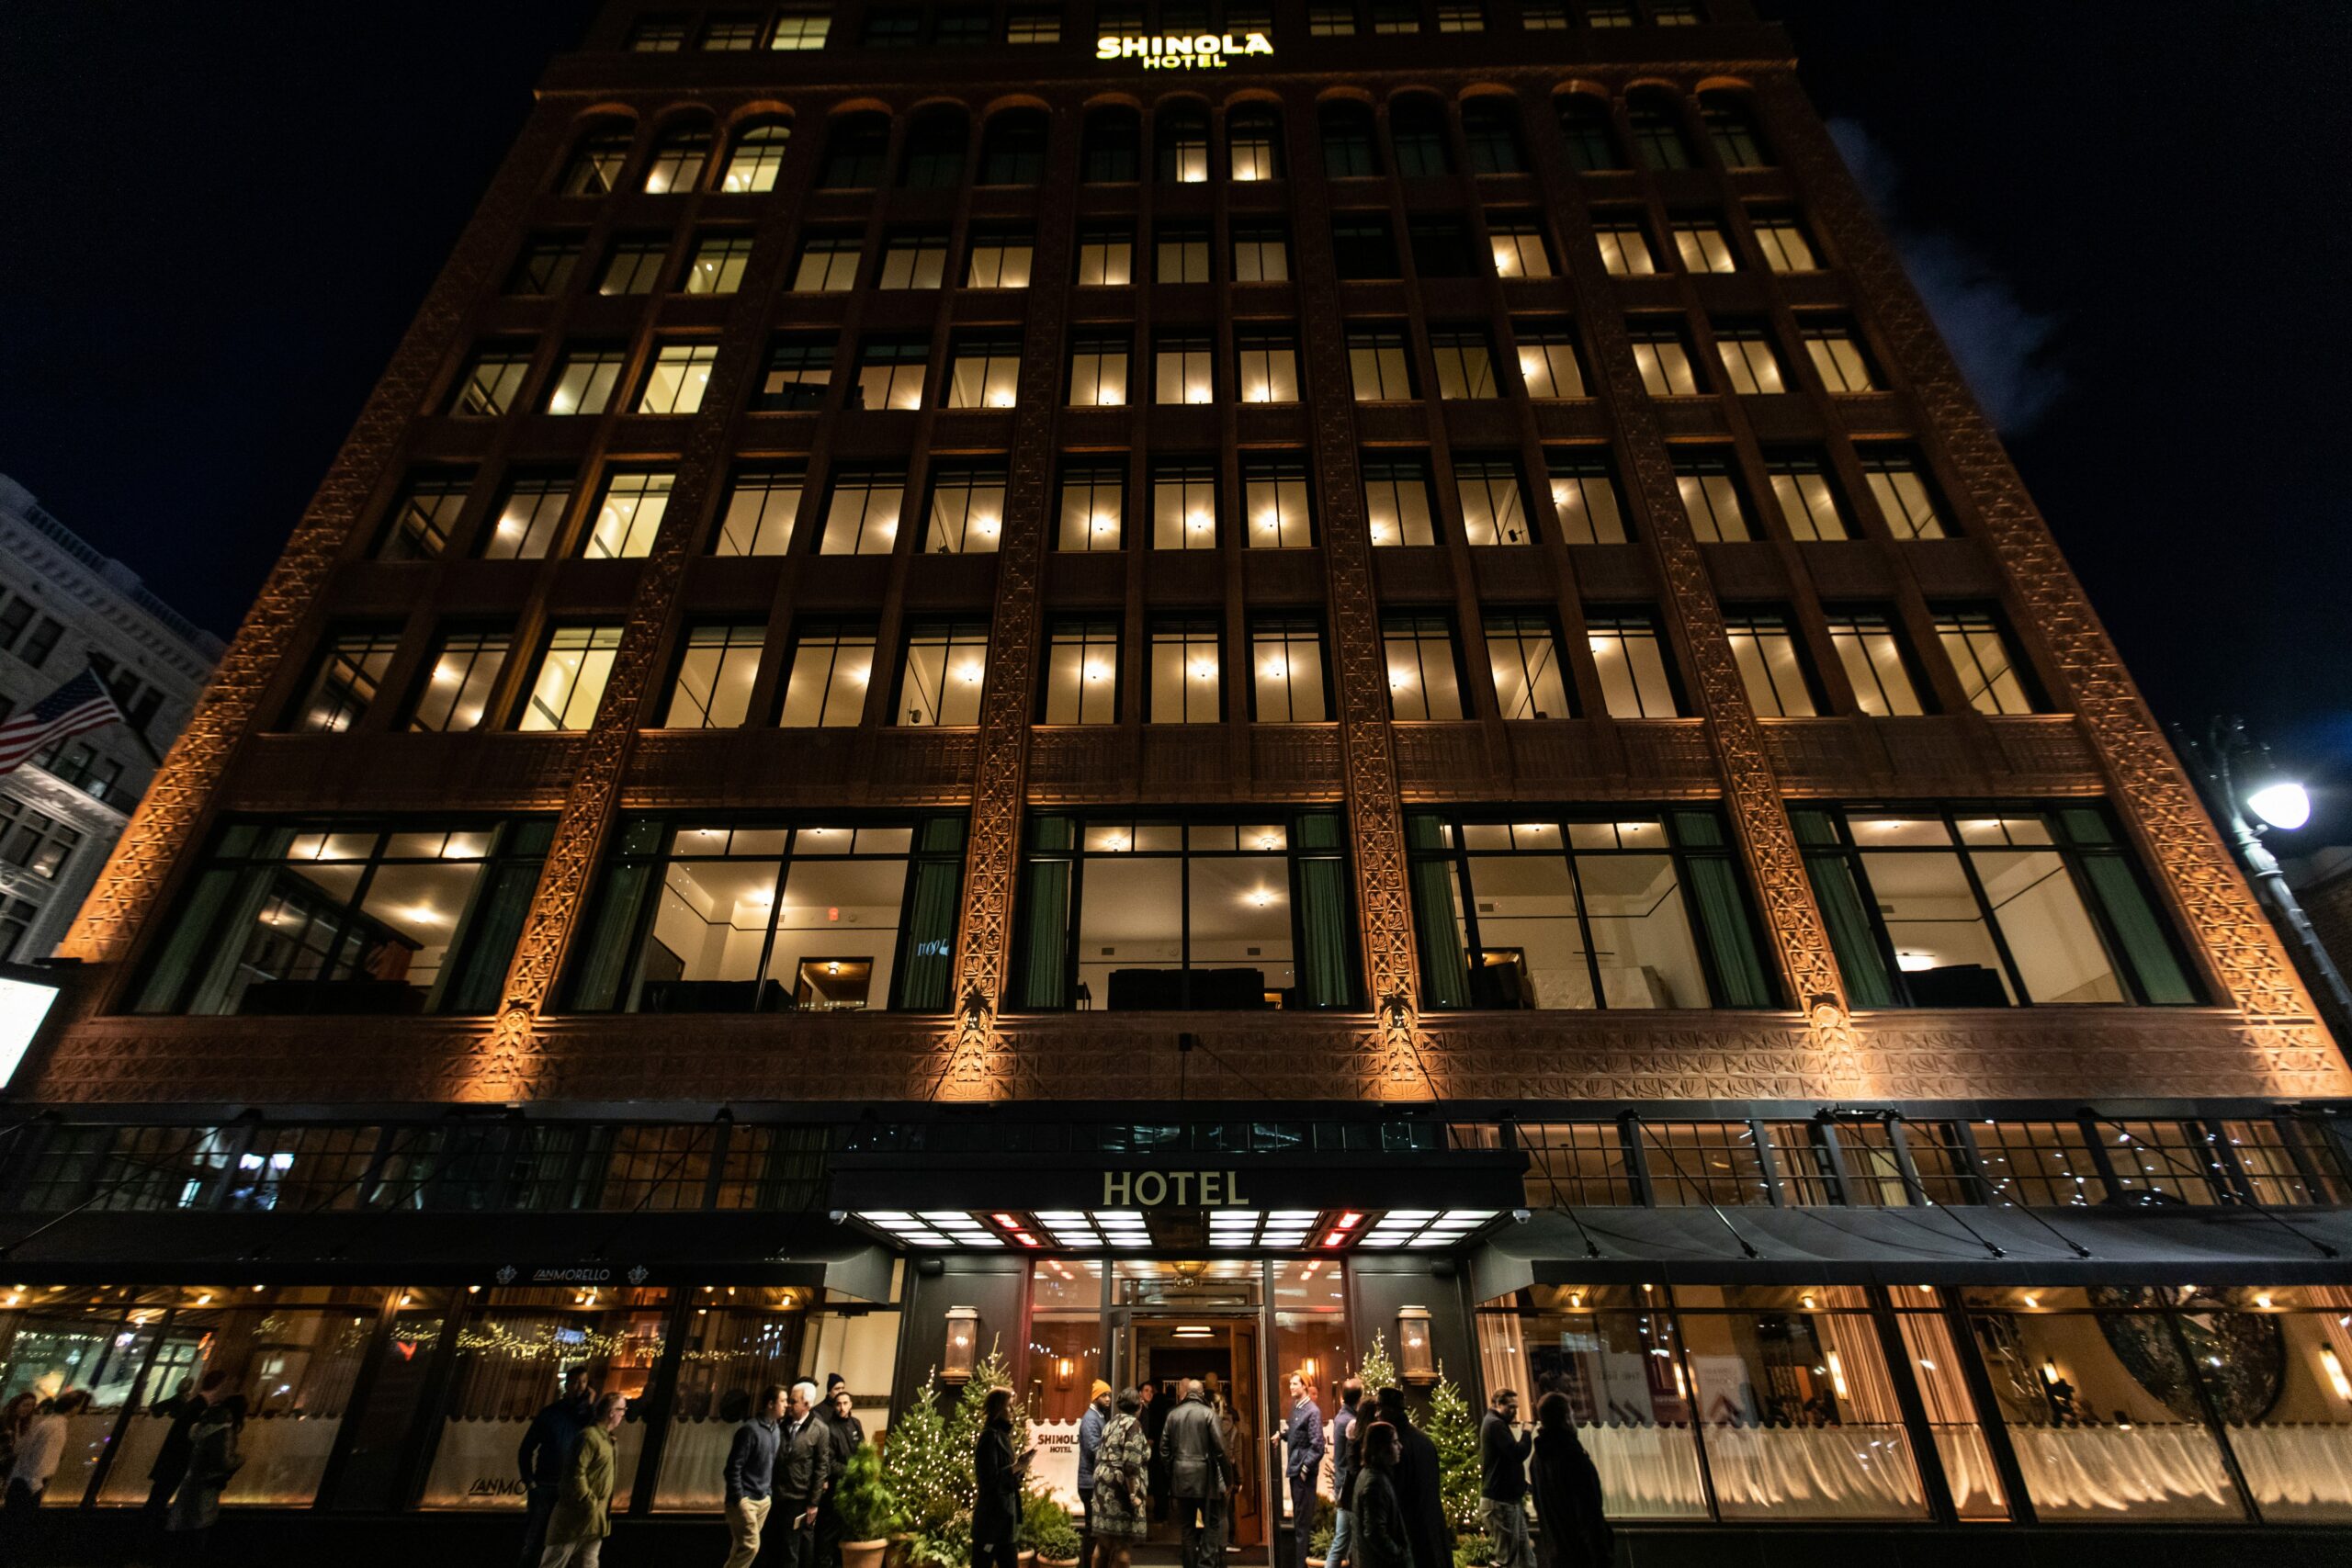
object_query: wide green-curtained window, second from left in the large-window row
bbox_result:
[570,816,965,1013]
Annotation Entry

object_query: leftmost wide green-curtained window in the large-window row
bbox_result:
[136,818,553,1016]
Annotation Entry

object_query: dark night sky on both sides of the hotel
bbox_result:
[0,0,2352,853]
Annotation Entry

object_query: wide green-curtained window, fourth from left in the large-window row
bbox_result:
[1407,807,1778,1009]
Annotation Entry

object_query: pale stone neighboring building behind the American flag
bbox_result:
[0,475,221,962]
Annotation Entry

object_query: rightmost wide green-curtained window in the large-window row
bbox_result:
[1792,807,2197,1009]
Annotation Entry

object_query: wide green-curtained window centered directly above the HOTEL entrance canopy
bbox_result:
[1013,811,1355,1010]
